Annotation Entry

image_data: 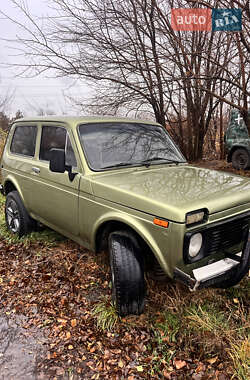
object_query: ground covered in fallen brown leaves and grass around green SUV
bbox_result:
[0,164,250,380]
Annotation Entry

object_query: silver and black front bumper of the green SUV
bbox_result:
[174,230,250,291]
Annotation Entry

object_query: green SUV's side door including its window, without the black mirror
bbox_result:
[30,124,80,236]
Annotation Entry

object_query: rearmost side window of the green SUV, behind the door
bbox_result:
[10,125,37,157]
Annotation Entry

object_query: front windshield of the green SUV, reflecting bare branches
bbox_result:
[79,122,186,171]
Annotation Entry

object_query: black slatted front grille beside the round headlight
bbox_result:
[205,218,248,255]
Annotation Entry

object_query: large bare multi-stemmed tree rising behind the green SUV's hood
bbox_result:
[3,0,250,159]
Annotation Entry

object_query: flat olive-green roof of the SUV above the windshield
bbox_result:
[13,116,160,125]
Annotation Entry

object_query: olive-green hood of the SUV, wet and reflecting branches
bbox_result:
[92,165,250,223]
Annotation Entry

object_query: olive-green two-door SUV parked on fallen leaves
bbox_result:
[1,117,250,315]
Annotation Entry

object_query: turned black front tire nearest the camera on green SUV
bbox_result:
[109,231,146,316]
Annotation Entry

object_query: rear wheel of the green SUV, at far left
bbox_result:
[5,191,35,237]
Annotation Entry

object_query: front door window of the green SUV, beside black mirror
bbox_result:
[39,126,77,167]
